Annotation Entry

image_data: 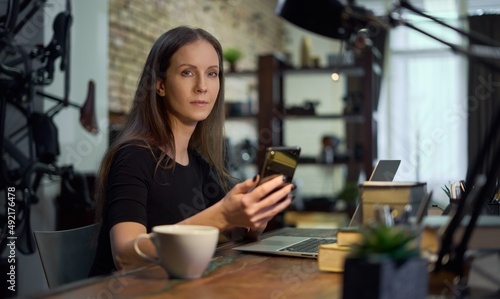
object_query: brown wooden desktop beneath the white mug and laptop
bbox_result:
[37,228,342,299]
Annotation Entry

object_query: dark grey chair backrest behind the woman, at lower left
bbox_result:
[33,223,100,288]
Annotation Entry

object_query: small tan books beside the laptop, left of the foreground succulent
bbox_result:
[318,227,362,272]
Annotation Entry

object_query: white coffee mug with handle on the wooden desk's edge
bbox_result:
[134,224,219,279]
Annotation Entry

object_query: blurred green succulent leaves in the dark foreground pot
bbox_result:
[350,223,420,262]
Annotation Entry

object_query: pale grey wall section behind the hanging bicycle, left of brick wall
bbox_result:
[46,0,108,173]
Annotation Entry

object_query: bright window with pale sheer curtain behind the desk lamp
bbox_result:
[377,17,467,206]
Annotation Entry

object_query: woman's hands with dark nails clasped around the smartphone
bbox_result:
[222,175,293,230]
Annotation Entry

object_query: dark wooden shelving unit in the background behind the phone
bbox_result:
[257,49,381,182]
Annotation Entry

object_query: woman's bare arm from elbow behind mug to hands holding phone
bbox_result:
[110,176,293,270]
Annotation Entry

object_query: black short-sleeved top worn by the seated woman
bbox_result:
[89,145,225,276]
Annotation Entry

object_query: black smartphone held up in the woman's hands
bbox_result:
[259,146,300,185]
